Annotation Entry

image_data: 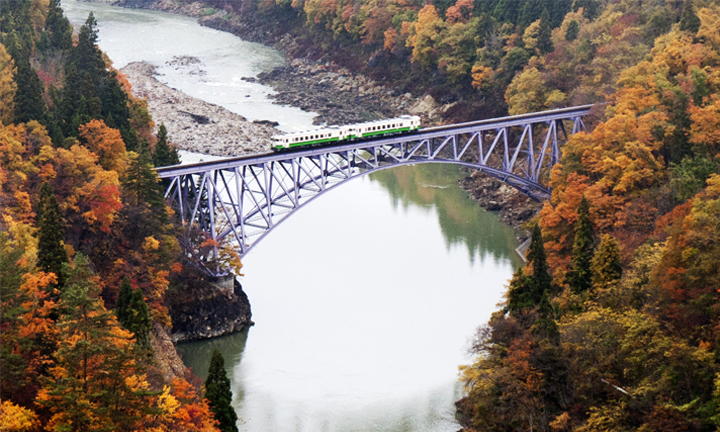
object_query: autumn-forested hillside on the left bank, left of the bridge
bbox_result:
[0,0,239,431]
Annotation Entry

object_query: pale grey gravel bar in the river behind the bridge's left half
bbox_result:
[120,57,279,156]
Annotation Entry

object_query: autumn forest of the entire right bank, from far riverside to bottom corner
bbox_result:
[194,0,720,426]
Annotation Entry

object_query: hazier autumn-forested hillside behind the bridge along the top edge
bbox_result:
[179,0,692,121]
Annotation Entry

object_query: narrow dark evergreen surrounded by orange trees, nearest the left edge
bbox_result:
[36,182,68,288]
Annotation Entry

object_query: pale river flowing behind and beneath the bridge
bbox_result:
[63,0,520,432]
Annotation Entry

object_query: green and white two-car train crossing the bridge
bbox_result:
[272,115,420,151]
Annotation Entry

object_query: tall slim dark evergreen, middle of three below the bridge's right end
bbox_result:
[567,196,595,293]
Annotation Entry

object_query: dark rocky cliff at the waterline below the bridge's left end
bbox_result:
[166,274,253,342]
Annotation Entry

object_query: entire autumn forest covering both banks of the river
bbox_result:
[0,0,720,432]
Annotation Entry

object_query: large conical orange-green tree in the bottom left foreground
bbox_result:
[36,253,151,431]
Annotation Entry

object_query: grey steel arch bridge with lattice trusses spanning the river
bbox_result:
[157,105,594,276]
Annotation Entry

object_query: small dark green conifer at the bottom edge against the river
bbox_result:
[205,348,238,432]
